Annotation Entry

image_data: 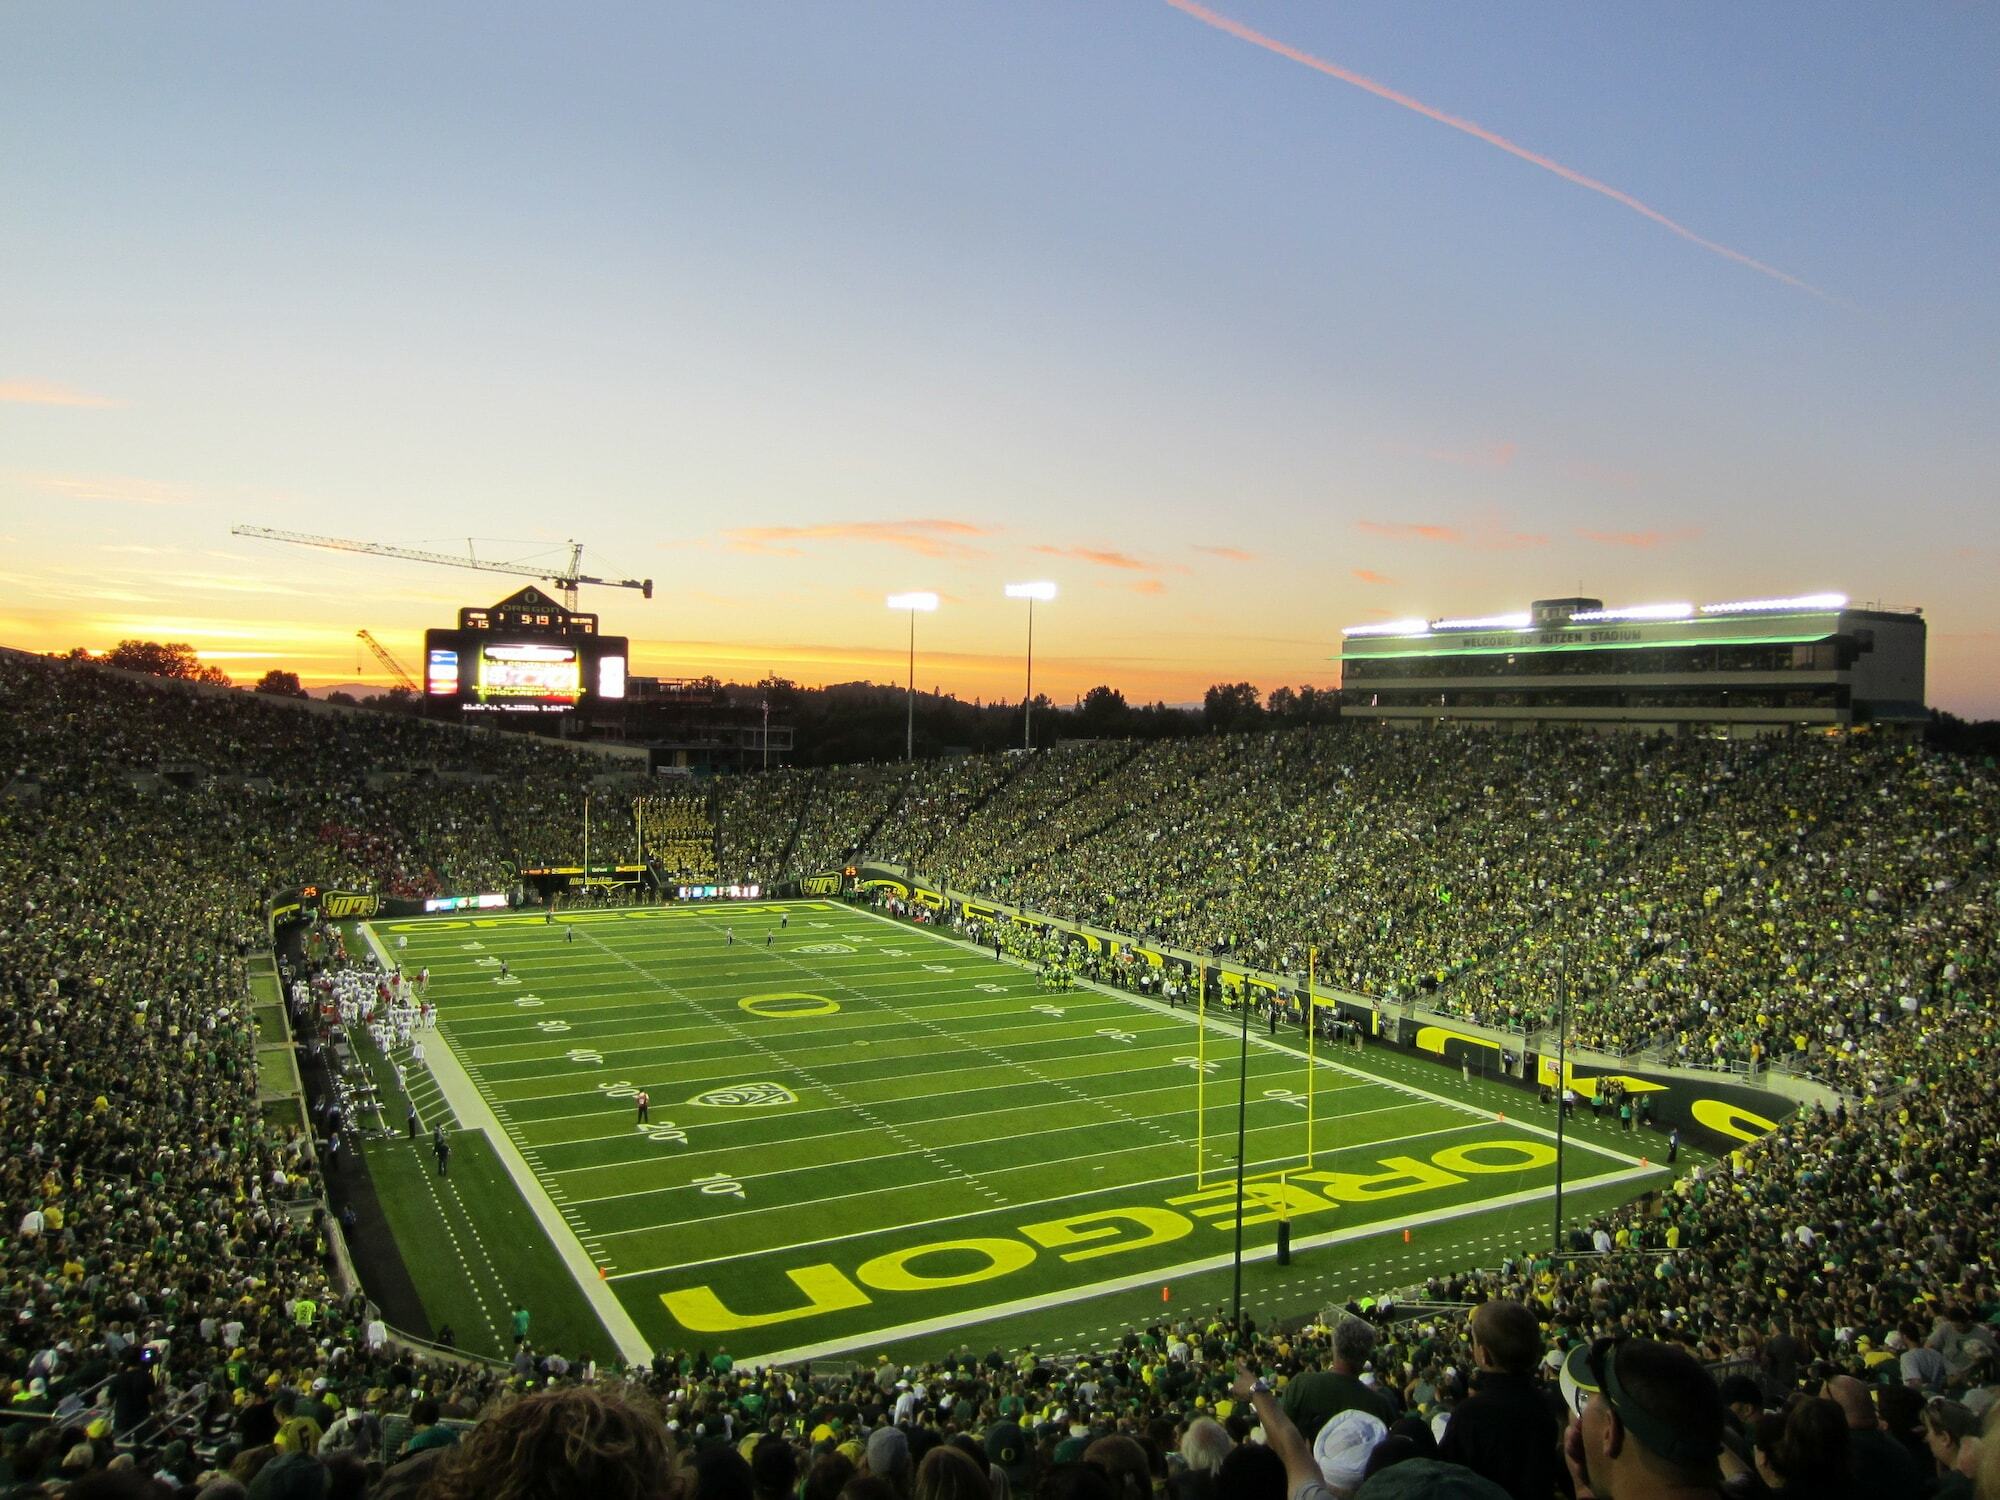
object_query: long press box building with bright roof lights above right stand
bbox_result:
[1340,594,1926,734]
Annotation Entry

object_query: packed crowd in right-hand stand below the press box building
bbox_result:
[708,726,2000,1094]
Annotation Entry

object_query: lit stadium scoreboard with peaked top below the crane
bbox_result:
[424,588,628,718]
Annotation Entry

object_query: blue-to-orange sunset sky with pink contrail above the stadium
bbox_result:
[0,0,2000,716]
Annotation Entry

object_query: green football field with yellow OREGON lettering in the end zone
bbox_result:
[356,902,1666,1358]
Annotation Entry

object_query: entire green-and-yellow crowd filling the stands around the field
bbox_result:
[0,656,2000,1500]
